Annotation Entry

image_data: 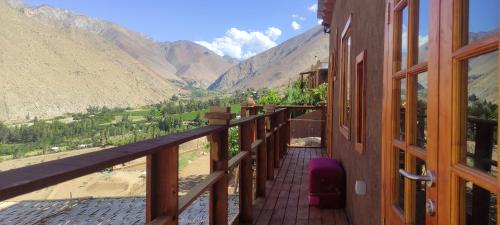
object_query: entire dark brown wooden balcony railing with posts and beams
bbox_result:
[0,106,304,225]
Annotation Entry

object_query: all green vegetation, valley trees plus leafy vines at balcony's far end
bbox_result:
[0,80,327,160]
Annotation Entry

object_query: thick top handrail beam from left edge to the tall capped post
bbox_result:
[0,126,226,201]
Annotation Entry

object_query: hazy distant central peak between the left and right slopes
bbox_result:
[161,41,235,88]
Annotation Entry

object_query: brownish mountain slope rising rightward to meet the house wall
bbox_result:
[209,26,329,92]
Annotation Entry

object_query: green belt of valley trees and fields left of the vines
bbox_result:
[0,96,240,158]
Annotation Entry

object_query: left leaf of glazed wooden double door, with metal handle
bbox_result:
[382,0,438,225]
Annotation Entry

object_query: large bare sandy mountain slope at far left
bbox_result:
[0,0,179,121]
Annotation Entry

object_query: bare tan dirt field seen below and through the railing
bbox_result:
[0,138,210,201]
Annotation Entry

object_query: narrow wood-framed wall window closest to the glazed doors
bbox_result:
[354,51,366,154]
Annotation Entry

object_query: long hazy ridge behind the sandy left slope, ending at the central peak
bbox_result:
[19,3,233,87]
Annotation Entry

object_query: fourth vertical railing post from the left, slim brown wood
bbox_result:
[256,117,267,197]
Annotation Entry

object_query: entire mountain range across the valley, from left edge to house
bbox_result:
[0,0,328,121]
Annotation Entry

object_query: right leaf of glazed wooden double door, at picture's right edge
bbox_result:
[438,0,500,225]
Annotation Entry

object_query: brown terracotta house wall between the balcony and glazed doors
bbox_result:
[328,0,385,225]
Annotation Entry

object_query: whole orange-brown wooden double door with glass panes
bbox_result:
[382,0,500,225]
